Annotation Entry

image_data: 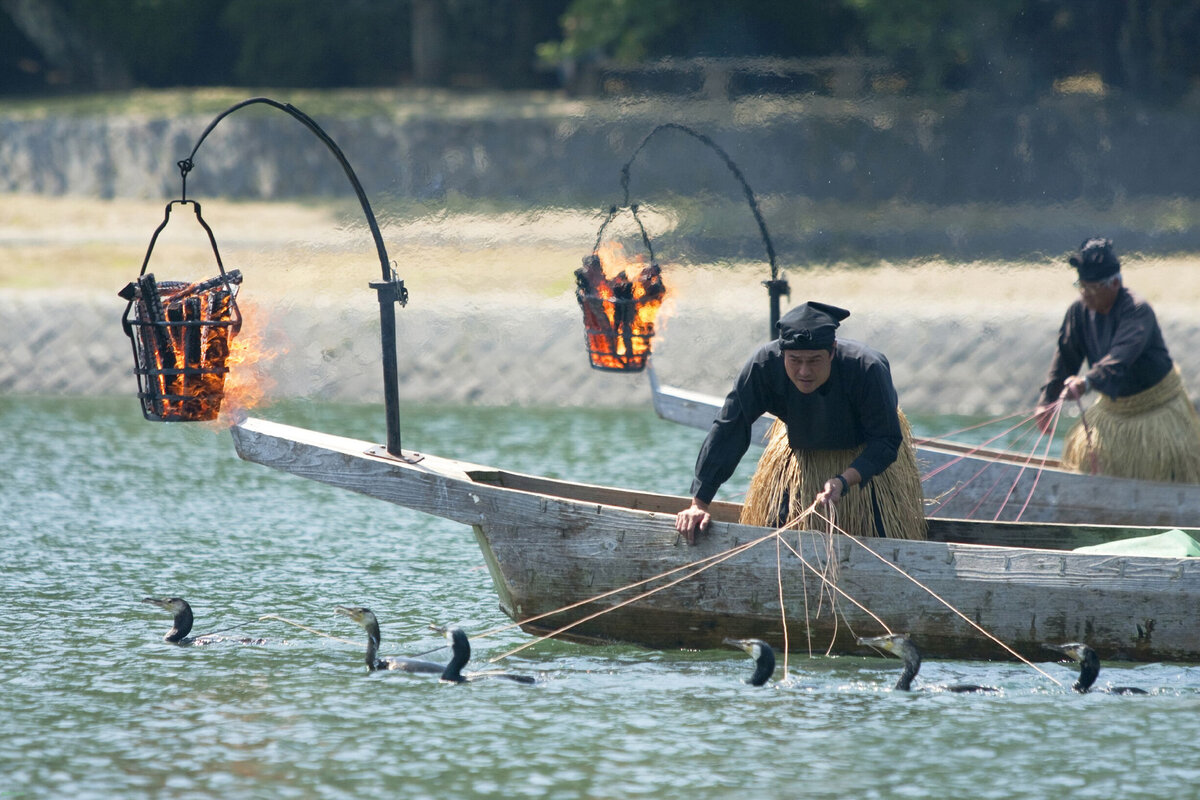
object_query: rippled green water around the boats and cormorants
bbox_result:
[0,397,1200,800]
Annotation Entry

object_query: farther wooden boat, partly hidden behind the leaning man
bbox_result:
[648,366,1200,528]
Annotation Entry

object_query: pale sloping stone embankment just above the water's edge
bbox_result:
[7,291,1200,416]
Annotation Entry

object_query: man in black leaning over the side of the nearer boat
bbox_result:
[676,302,925,541]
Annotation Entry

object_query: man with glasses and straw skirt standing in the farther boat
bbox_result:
[1037,237,1200,483]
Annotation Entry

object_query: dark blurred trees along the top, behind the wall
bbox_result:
[0,0,1200,103]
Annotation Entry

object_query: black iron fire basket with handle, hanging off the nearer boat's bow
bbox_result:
[118,200,241,422]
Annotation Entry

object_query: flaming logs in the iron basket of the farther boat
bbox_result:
[575,245,666,372]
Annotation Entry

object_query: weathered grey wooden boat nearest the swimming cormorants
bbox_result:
[232,419,1200,661]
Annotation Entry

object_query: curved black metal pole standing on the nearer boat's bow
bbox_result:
[179,97,408,457]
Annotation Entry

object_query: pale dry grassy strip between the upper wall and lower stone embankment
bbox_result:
[0,196,1200,317]
